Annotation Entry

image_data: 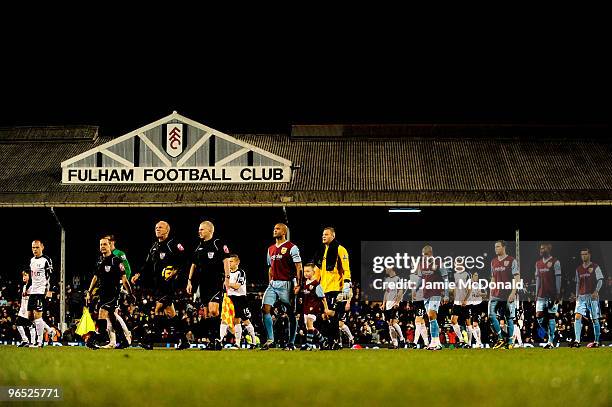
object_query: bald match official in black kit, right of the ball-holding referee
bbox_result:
[187,221,230,350]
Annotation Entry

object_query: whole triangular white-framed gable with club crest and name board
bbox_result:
[62,112,292,184]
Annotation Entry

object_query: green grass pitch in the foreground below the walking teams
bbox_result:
[0,346,612,407]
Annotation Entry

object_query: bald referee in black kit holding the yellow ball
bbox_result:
[132,221,189,349]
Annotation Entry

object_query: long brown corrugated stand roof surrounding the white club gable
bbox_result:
[0,125,612,206]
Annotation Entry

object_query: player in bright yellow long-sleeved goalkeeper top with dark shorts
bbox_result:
[314,227,352,349]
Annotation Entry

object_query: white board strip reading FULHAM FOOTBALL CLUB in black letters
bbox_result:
[62,166,291,184]
